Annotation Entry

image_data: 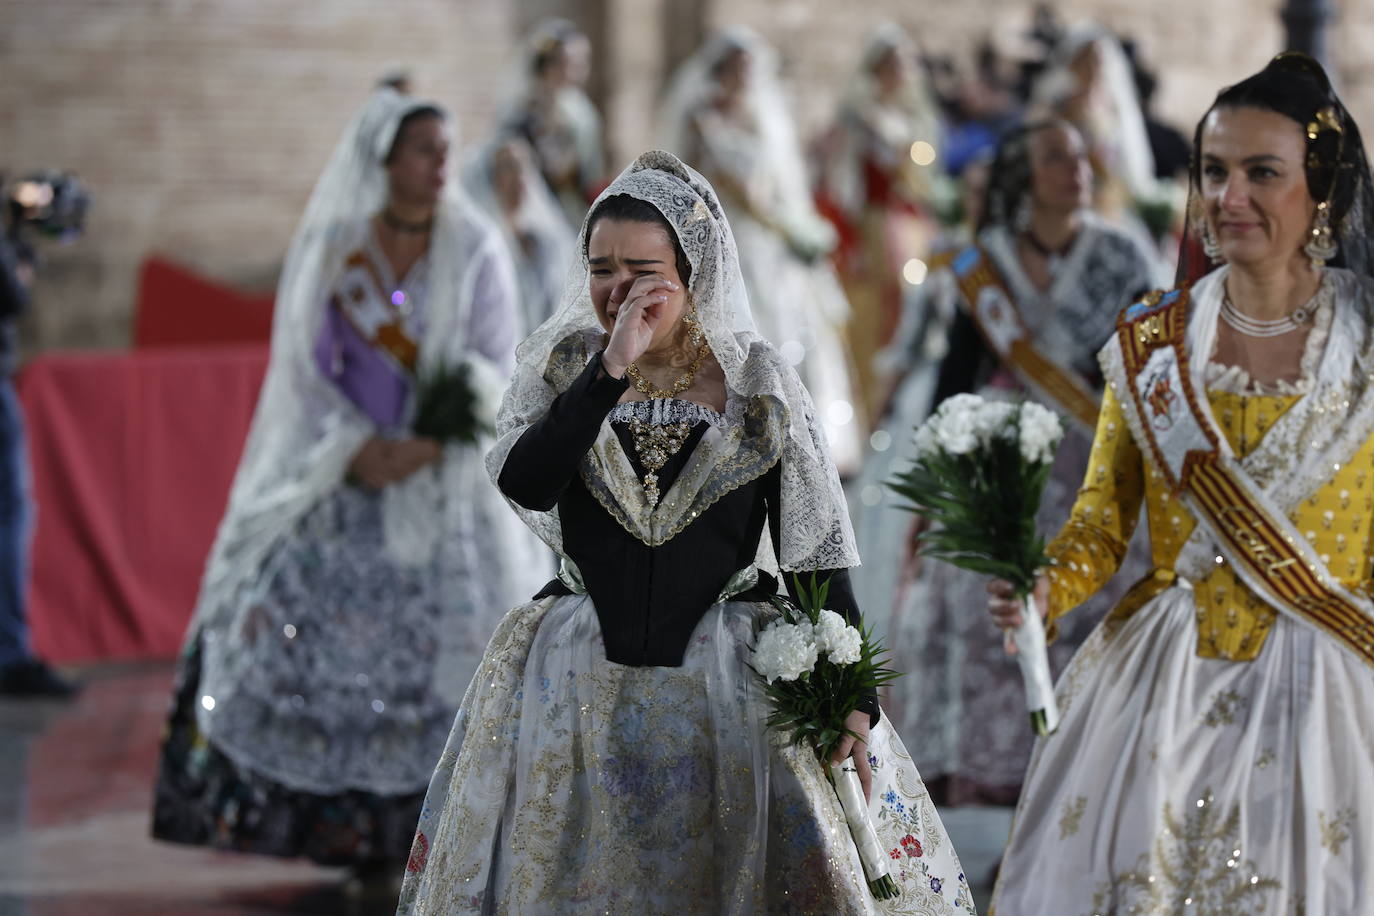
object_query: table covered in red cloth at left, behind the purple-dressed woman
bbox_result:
[19,345,268,662]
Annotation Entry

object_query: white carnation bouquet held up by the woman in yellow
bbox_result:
[888,394,1063,735]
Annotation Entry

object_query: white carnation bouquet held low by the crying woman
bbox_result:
[750,577,900,900]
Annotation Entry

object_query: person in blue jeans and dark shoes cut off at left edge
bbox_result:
[0,175,76,698]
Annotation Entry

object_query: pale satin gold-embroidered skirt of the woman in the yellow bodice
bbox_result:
[993,588,1374,916]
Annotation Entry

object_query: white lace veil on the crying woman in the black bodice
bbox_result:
[486,151,859,570]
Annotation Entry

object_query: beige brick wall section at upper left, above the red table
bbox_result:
[0,0,513,352]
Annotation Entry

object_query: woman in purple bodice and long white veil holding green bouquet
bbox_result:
[153,89,541,895]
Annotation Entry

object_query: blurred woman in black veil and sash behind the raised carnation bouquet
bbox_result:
[868,121,1158,805]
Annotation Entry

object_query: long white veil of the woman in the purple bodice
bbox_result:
[192,88,514,633]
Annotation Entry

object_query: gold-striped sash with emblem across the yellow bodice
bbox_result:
[1102,290,1374,665]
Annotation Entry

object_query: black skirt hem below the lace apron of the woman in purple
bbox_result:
[153,637,425,865]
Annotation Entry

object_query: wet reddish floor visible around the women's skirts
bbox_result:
[0,665,1010,916]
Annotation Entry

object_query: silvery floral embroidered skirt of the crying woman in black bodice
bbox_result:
[400,596,974,916]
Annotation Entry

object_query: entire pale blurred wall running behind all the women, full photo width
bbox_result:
[0,0,1374,352]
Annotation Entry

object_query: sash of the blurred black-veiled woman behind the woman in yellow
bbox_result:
[949,244,1099,433]
